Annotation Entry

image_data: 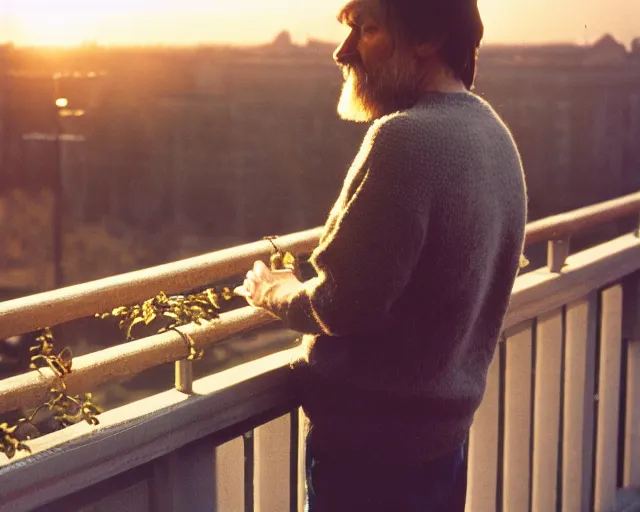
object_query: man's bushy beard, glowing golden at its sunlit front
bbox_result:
[338,54,421,123]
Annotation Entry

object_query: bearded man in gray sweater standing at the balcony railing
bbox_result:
[236,0,526,512]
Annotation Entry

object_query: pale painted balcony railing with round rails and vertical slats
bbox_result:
[0,193,640,512]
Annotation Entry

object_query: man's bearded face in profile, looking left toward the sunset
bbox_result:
[334,0,420,122]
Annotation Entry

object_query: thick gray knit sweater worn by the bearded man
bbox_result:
[276,93,526,464]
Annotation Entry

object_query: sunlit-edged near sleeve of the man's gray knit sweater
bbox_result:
[275,118,429,336]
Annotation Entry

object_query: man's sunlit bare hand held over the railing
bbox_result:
[234,261,303,313]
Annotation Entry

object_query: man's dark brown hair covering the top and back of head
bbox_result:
[380,0,484,90]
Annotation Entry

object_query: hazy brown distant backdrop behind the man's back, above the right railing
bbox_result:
[477,36,640,218]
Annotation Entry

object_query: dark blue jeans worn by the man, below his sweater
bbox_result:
[305,436,467,512]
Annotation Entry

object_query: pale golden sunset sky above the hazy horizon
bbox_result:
[0,0,640,45]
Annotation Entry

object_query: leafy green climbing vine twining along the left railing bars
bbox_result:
[0,237,297,459]
